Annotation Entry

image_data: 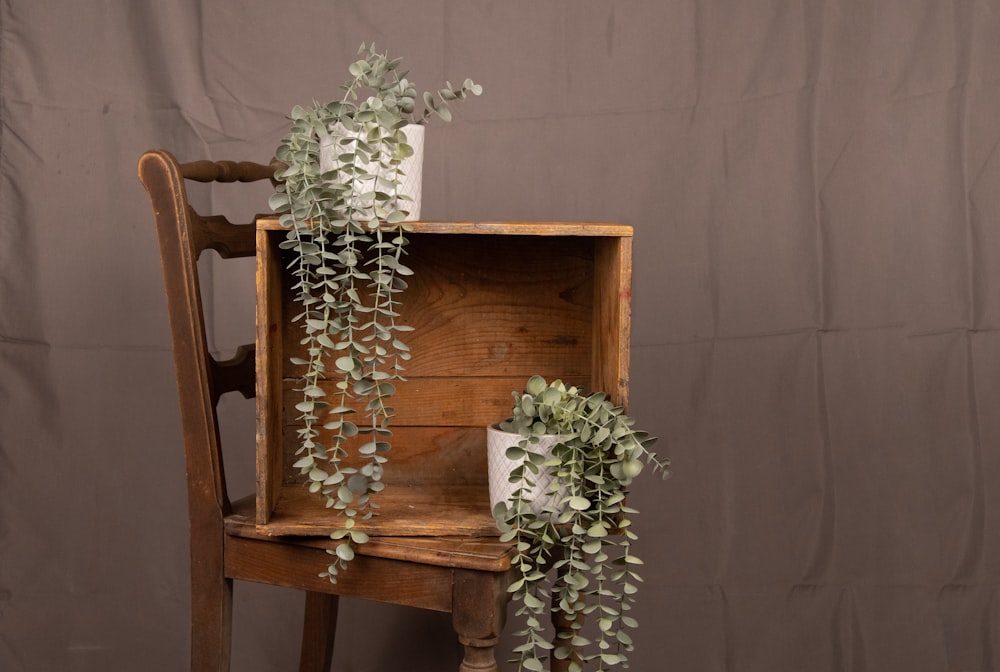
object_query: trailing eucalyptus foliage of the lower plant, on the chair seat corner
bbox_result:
[493,376,670,672]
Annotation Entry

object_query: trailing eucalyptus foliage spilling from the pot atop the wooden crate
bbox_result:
[269,44,482,582]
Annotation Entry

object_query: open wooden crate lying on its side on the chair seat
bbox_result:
[257,217,632,536]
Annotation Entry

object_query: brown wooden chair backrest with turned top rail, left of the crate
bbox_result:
[139,150,276,525]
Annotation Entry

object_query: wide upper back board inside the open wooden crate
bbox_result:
[282,235,594,380]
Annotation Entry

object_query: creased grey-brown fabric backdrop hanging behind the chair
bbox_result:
[0,0,1000,672]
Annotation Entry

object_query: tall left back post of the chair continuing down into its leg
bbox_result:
[138,150,266,672]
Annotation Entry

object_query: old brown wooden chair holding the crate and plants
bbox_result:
[139,150,512,672]
